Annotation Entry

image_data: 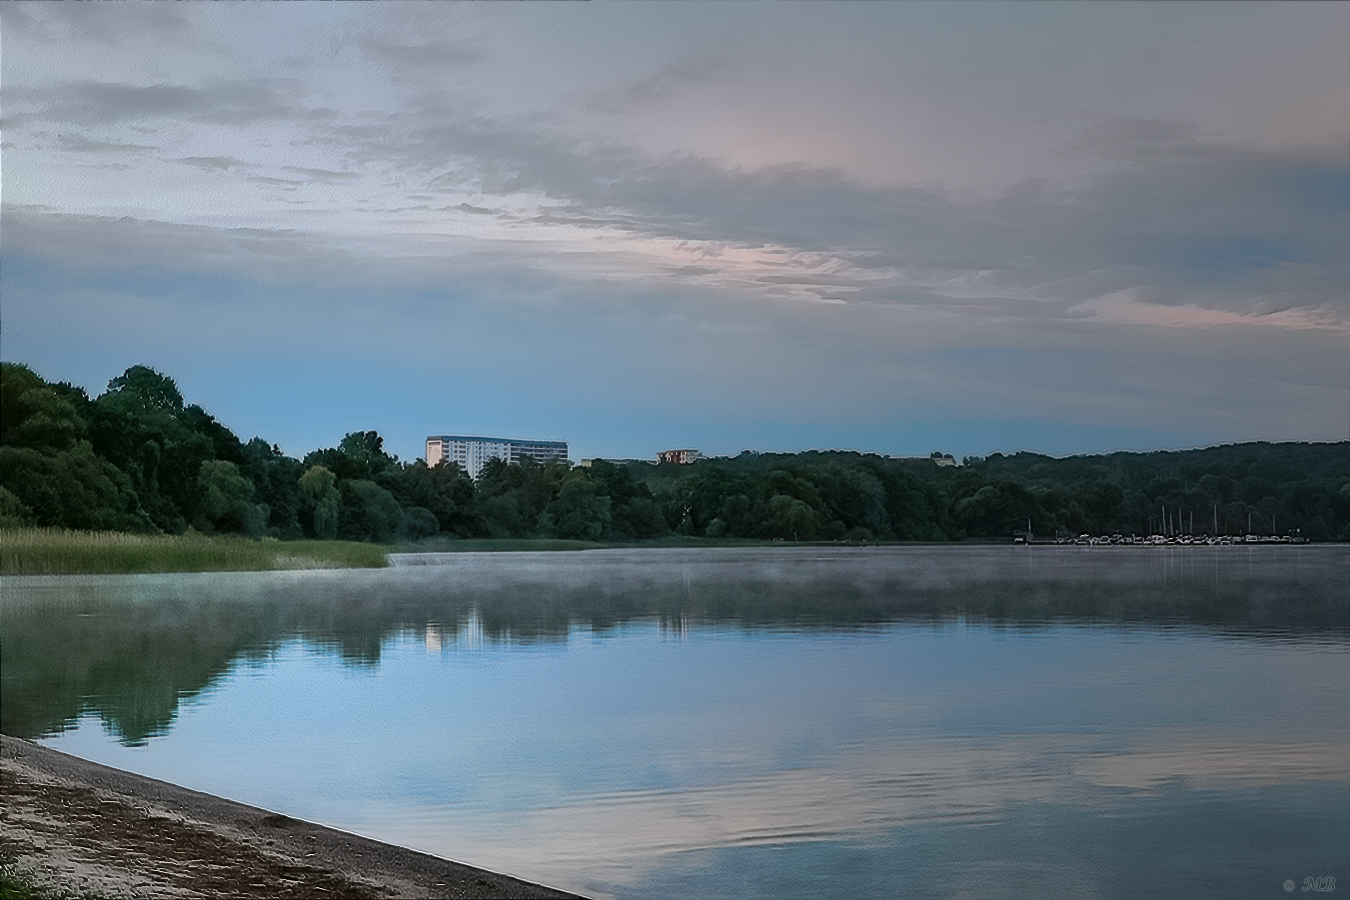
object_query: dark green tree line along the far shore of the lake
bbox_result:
[0,363,1350,544]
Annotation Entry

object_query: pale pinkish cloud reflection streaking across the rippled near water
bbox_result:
[366,734,1350,891]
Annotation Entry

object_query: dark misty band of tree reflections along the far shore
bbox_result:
[0,546,1350,745]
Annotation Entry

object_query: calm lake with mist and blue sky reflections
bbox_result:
[0,545,1350,899]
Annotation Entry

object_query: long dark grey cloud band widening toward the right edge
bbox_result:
[309,103,1350,319]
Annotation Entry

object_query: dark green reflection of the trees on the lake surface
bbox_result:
[0,555,1350,745]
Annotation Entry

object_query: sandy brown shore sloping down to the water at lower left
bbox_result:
[0,735,575,899]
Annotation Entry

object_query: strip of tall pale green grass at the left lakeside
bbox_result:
[0,528,387,575]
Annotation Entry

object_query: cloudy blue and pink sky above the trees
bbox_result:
[0,0,1350,460]
